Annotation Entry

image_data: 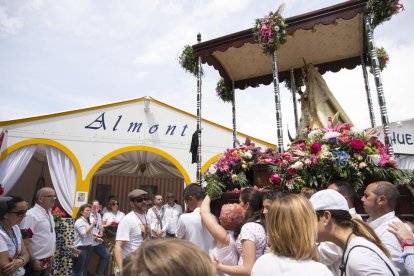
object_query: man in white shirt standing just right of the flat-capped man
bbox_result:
[147,195,168,239]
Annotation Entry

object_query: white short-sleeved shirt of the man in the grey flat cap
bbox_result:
[116,211,151,259]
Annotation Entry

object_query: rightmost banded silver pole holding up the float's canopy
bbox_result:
[364,14,394,157]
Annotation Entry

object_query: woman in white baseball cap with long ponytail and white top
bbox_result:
[310,189,398,276]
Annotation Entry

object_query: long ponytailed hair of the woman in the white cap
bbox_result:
[316,210,391,259]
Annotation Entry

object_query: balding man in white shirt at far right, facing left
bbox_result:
[361,181,408,275]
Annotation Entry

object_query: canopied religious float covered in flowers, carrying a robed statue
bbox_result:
[181,0,414,215]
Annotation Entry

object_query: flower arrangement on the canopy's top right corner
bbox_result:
[367,0,404,28]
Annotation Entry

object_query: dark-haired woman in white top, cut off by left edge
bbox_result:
[0,196,29,276]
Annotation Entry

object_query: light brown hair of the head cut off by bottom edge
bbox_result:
[123,238,216,276]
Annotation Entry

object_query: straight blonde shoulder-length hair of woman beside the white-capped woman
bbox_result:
[266,195,317,260]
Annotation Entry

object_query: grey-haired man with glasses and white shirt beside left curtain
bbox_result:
[20,187,56,276]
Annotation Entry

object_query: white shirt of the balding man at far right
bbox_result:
[367,211,408,275]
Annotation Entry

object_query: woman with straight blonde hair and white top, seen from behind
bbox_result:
[252,195,332,276]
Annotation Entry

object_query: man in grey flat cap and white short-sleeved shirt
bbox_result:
[114,189,151,271]
